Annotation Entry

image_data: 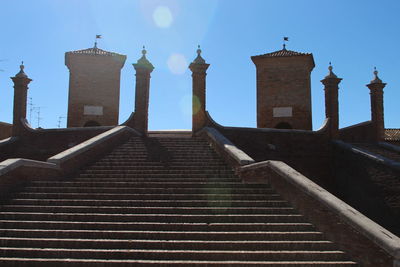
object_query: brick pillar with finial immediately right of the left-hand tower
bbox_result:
[132,47,154,135]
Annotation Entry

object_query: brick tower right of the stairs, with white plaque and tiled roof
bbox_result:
[251,45,315,130]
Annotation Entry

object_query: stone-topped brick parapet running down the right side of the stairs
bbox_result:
[203,128,400,267]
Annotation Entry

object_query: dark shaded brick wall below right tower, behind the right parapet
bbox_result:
[207,115,332,189]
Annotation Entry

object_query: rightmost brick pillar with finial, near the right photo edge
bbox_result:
[367,69,386,142]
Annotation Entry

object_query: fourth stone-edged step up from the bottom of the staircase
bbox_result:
[0,229,324,241]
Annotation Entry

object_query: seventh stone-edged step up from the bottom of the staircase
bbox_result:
[1,205,295,215]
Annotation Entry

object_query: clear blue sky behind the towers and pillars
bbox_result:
[0,0,400,130]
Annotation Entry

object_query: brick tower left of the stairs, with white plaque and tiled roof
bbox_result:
[65,44,126,127]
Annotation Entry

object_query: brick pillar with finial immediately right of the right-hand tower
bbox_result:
[321,65,342,139]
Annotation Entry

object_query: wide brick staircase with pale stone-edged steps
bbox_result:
[0,135,357,266]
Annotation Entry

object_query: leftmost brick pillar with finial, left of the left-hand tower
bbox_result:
[11,62,32,136]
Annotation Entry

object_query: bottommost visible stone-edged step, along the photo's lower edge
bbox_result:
[0,258,357,267]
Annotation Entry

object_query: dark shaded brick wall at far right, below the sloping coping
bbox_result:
[333,145,400,238]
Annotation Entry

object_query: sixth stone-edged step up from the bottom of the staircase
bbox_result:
[0,215,306,223]
